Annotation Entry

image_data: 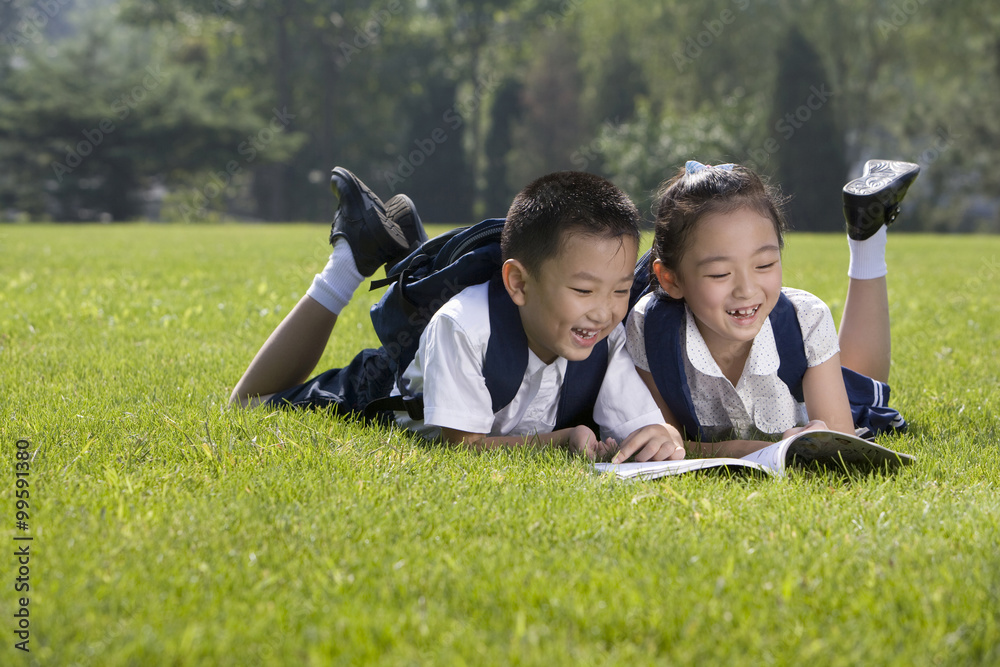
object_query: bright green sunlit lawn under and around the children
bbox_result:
[0,225,1000,666]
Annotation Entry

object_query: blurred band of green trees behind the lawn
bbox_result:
[0,0,1000,232]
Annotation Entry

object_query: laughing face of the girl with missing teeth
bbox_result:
[657,209,781,360]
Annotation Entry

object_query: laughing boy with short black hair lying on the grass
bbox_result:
[230,167,684,462]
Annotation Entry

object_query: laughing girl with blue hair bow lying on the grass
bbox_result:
[627,160,919,456]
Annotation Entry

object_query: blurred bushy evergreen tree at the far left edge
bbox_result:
[0,7,300,220]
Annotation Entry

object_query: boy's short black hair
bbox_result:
[500,171,639,274]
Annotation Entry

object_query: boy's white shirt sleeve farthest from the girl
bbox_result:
[420,316,494,433]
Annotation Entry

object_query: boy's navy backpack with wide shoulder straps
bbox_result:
[364,218,608,429]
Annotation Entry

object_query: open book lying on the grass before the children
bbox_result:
[594,431,916,479]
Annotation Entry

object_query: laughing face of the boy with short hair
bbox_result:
[511,231,638,363]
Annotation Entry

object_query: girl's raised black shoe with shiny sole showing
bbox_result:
[844,160,920,241]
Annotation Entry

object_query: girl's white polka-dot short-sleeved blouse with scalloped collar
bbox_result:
[626,287,840,440]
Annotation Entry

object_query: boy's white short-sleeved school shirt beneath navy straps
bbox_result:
[393,283,664,443]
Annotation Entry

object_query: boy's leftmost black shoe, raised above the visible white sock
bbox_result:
[330,167,410,276]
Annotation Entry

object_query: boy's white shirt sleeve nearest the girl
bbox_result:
[594,325,664,443]
